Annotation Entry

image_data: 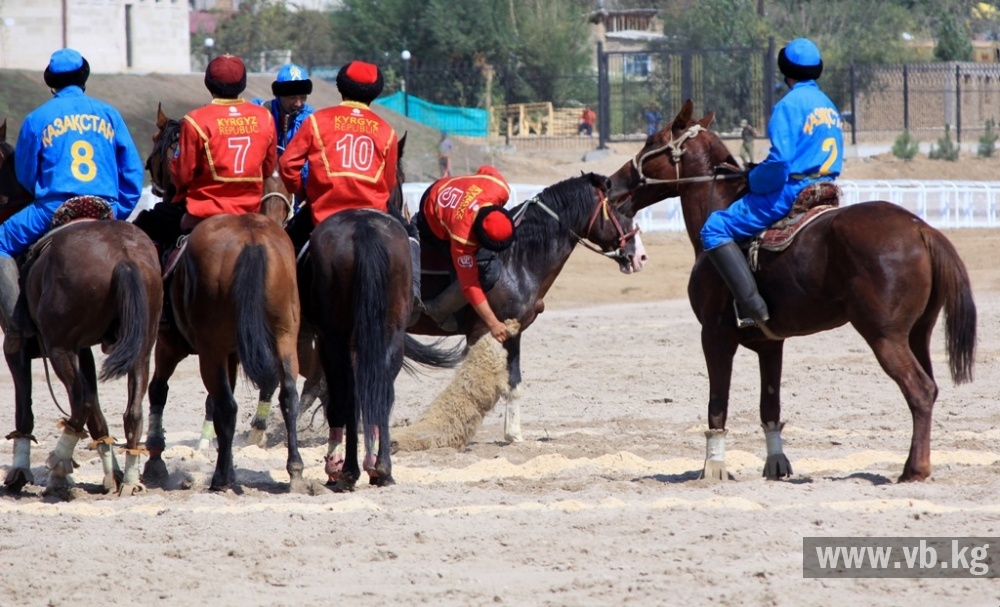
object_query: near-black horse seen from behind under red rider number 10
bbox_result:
[309,209,432,491]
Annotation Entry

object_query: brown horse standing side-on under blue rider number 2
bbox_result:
[611,101,976,481]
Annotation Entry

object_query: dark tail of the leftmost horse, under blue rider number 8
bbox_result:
[100,260,151,381]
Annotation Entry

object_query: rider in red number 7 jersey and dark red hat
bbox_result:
[135,55,277,318]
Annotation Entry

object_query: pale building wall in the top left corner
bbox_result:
[0,0,191,74]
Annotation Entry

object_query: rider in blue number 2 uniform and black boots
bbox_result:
[701,38,844,327]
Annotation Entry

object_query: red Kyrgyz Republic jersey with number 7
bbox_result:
[170,99,278,218]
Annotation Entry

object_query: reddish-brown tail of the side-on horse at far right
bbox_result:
[923,230,976,384]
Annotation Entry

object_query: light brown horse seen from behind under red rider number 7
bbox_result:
[144,111,305,491]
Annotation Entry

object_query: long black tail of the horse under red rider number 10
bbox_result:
[352,221,396,440]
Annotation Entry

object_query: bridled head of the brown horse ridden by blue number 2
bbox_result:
[608,99,739,217]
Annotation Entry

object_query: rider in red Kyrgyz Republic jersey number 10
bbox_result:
[278,61,422,319]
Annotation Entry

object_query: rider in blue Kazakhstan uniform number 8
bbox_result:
[0,48,144,353]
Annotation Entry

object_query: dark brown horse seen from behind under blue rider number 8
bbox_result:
[0,123,163,495]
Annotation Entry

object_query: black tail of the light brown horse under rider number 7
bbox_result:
[232,244,278,390]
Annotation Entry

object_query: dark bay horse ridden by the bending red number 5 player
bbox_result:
[409,173,646,442]
